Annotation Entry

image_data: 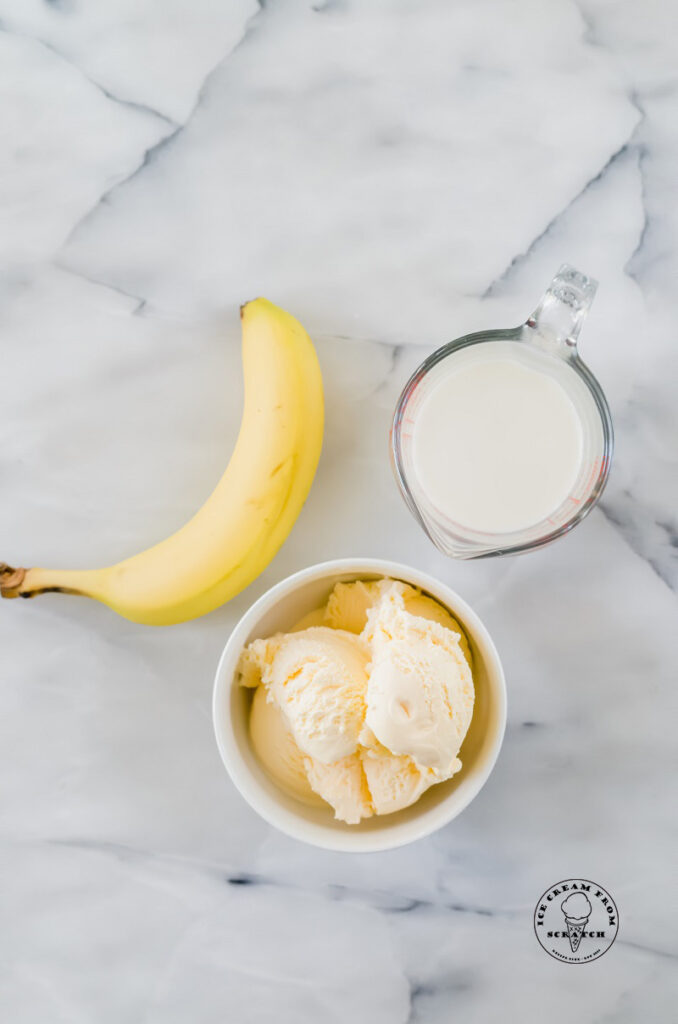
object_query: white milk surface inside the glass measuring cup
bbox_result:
[412,343,583,534]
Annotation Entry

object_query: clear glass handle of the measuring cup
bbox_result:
[526,263,598,355]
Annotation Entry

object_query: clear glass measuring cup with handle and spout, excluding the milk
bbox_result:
[391,264,615,558]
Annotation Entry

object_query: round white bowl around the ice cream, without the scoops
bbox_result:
[212,558,506,853]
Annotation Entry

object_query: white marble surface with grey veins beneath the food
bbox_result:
[0,0,678,1024]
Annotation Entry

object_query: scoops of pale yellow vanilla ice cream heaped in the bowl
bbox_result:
[240,580,474,824]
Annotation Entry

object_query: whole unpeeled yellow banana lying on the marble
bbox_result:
[0,299,324,626]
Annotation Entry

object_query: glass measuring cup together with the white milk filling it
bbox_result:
[391,266,613,558]
